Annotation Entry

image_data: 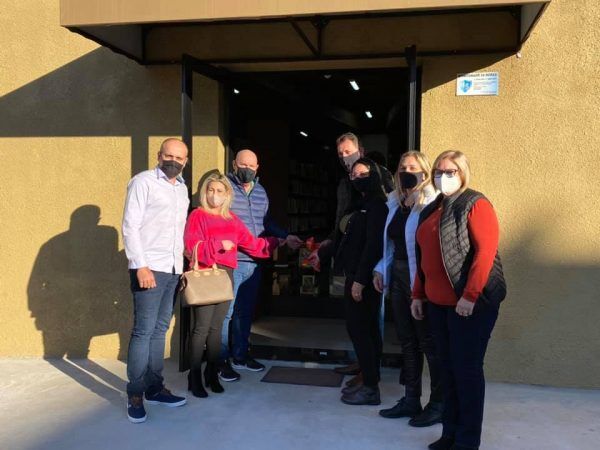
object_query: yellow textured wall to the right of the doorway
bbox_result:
[421,0,600,387]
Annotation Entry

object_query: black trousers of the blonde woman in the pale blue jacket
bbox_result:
[390,260,443,402]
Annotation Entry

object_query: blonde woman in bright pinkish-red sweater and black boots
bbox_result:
[183,174,280,397]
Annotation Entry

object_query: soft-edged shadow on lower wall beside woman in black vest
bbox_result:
[486,214,600,388]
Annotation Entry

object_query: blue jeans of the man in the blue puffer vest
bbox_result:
[221,261,261,361]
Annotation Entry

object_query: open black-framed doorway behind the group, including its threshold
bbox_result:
[179,58,421,370]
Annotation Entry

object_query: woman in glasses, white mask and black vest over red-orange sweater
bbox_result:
[411,150,506,450]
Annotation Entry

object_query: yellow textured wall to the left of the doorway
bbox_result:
[0,0,225,358]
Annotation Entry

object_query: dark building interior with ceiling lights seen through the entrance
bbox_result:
[227,69,420,358]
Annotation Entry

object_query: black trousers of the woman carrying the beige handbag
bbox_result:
[190,301,231,370]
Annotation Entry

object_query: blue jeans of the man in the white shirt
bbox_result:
[127,270,179,396]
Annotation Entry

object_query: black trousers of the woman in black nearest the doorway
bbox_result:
[344,277,383,387]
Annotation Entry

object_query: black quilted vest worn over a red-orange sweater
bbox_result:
[416,189,506,305]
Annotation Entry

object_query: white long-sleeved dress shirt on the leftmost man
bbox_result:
[123,166,190,274]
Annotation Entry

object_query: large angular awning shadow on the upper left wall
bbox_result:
[0,48,183,176]
